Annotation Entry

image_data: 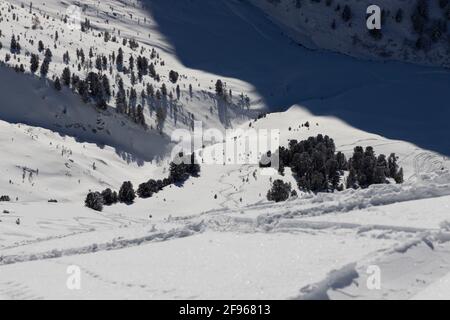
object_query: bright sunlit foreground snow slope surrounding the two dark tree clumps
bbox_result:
[0,107,450,299]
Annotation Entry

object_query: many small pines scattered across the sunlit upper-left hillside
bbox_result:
[0,5,255,133]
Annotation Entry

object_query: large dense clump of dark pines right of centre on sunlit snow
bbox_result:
[261,134,403,201]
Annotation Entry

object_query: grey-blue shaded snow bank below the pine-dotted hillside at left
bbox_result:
[0,67,171,161]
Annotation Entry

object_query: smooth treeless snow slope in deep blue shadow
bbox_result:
[138,0,450,155]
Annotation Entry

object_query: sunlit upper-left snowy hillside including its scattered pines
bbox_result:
[0,0,258,139]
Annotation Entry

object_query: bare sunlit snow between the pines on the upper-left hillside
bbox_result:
[0,0,261,135]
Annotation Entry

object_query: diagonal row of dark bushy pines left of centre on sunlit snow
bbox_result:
[84,153,200,211]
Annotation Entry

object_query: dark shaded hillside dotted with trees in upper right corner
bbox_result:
[250,0,450,67]
